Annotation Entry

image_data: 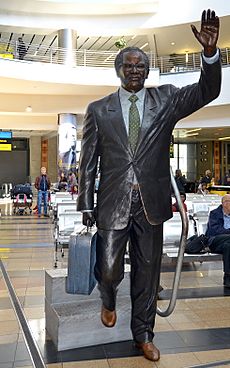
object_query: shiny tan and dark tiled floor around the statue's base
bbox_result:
[0,203,230,368]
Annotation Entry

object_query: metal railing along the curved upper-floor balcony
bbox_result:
[0,40,230,74]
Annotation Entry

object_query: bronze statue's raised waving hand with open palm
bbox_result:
[191,9,220,57]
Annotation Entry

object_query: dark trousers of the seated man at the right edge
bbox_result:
[209,234,230,274]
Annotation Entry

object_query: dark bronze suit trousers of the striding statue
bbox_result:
[95,191,163,342]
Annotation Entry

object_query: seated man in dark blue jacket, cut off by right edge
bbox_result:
[205,194,230,288]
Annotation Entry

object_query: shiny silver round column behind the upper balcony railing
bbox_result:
[58,28,77,67]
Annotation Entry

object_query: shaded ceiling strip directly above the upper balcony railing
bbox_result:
[0,15,230,56]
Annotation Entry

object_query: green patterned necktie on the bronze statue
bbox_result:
[129,95,140,152]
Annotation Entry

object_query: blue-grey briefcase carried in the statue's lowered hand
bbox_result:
[66,229,97,295]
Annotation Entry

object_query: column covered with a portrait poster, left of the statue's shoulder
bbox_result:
[57,113,77,176]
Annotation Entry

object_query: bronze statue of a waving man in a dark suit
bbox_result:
[77,9,221,361]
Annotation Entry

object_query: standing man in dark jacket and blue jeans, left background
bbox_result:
[34,167,51,217]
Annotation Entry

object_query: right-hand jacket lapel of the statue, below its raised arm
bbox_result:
[136,89,157,153]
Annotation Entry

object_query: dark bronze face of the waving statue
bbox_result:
[118,51,149,92]
